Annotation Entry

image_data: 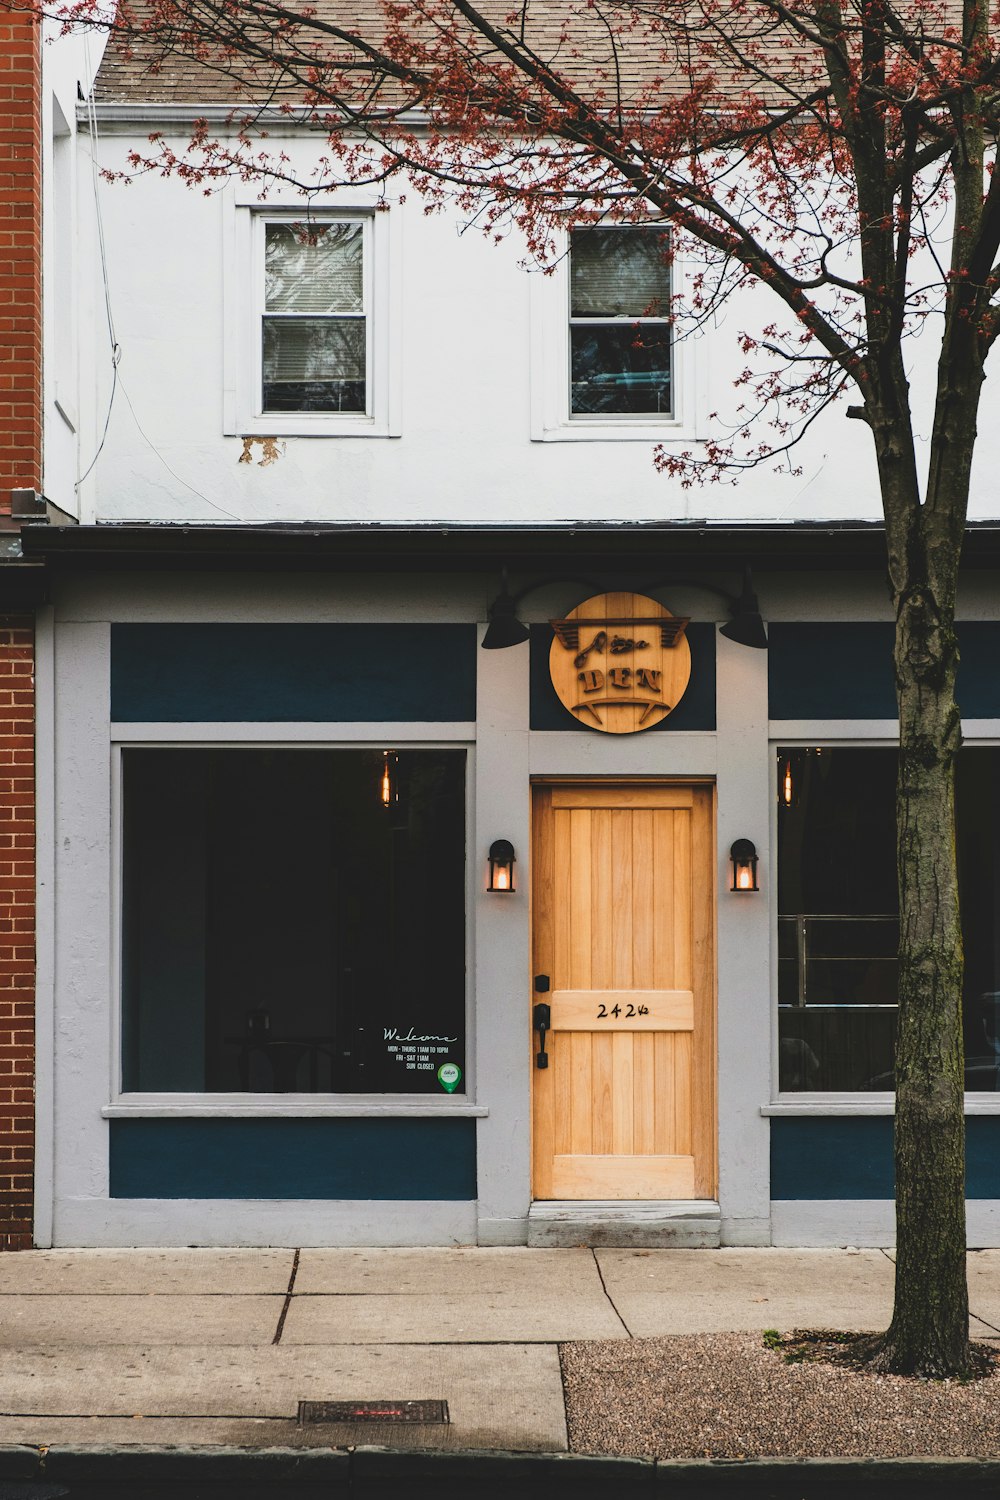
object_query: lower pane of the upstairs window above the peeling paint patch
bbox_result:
[262,318,367,411]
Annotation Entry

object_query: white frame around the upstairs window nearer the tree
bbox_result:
[529,225,706,446]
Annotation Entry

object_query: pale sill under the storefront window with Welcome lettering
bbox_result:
[100,1094,489,1121]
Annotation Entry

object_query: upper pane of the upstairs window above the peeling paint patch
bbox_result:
[264,224,364,312]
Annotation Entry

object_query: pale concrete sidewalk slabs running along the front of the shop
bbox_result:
[0,1250,1000,1454]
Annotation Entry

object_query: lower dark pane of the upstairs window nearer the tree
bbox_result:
[570,323,670,416]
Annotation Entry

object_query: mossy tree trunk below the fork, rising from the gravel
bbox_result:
[876,567,970,1377]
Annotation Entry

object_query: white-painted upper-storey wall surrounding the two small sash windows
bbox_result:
[66,115,997,525]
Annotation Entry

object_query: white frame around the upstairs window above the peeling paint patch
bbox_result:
[223,185,402,438]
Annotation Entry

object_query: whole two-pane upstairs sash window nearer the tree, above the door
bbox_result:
[570,227,673,419]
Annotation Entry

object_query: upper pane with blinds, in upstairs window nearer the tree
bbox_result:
[570,228,670,318]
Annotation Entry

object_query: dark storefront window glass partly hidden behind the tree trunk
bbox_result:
[777,747,1000,1092]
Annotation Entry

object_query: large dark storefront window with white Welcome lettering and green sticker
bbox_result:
[123,749,465,1097]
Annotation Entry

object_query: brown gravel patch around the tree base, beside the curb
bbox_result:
[561,1334,1000,1458]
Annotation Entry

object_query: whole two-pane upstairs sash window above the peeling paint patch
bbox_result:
[261,221,370,413]
